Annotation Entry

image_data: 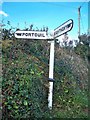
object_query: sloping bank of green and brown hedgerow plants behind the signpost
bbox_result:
[2,24,88,120]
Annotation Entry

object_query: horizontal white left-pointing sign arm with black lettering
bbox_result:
[15,31,47,40]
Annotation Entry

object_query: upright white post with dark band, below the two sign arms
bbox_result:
[48,40,54,109]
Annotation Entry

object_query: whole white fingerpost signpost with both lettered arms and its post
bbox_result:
[15,19,73,110]
